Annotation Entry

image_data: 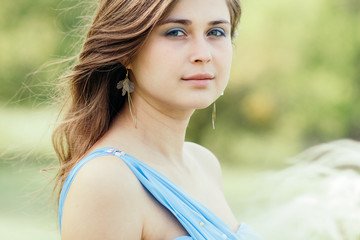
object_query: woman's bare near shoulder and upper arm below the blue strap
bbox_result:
[61,156,144,240]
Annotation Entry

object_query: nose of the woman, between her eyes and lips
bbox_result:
[190,38,212,63]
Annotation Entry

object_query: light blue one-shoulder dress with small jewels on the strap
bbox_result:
[59,147,262,240]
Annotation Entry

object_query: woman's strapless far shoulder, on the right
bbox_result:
[184,142,222,185]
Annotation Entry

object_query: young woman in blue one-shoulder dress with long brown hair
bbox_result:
[53,0,260,240]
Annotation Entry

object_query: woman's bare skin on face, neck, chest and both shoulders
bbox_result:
[61,0,238,240]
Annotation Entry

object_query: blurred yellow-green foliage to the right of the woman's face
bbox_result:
[189,0,360,167]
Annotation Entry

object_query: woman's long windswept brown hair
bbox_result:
[52,0,241,199]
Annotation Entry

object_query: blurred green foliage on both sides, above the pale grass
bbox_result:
[0,0,360,167]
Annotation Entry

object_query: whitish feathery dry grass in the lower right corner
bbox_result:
[238,140,360,240]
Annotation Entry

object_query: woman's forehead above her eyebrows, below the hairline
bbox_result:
[168,0,230,21]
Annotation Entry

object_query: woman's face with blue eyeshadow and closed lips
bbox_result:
[129,0,232,110]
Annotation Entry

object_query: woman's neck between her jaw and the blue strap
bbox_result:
[105,96,194,164]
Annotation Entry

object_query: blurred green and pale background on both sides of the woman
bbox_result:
[0,0,360,240]
